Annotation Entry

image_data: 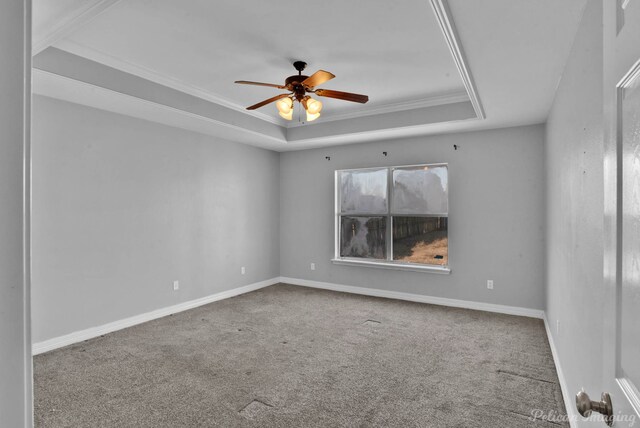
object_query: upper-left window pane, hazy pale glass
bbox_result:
[340,169,387,214]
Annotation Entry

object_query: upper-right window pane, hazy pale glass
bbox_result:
[391,165,449,214]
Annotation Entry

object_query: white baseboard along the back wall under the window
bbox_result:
[280,277,544,319]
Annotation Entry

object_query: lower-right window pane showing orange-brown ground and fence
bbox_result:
[393,216,449,265]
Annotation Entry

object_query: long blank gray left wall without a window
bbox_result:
[32,96,279,342]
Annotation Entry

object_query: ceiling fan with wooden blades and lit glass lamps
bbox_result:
[235,61,369,122]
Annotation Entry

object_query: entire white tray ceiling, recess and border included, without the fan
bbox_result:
[33,0,586,150]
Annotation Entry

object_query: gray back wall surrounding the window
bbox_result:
[280,125,545,309]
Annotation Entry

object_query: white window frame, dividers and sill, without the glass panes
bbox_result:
[331,163,451,274]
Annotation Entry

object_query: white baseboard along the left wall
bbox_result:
[31,277,280,355]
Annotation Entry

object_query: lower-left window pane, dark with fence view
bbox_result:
[340,217,387,259]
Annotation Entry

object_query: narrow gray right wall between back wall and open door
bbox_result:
[545,0,604,412]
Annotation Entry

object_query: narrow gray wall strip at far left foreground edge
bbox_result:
[0,0,31,427]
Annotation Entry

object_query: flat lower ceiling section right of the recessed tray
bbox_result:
[449,0,586,125]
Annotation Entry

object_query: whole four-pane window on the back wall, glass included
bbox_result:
[333,164,449,272]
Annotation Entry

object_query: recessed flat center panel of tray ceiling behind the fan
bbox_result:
[56,0,464,124]
